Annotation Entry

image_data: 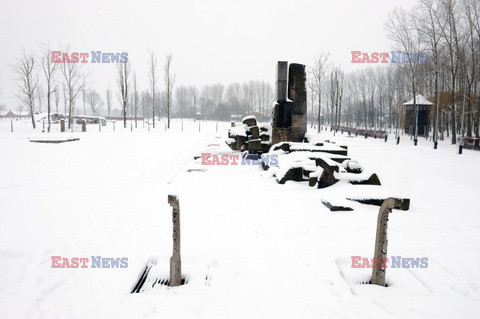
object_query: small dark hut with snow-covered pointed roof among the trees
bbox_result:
[403,94,433,135]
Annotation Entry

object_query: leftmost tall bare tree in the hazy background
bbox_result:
[11,50,38,129]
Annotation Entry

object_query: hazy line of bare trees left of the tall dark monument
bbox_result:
[6,45,273,131]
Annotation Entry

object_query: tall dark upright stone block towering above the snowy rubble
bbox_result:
[272,61,307,144]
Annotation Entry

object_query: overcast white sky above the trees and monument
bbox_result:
[0,0,414,109]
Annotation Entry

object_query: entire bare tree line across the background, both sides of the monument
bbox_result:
[4,0,480,143]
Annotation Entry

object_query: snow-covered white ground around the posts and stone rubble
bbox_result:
[0,121,480,318]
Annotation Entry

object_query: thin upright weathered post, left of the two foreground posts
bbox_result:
[168,195,182,287]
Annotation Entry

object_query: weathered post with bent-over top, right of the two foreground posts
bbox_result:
[372,197,410,287]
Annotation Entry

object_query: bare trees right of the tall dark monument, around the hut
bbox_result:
[308,0,480,144]
